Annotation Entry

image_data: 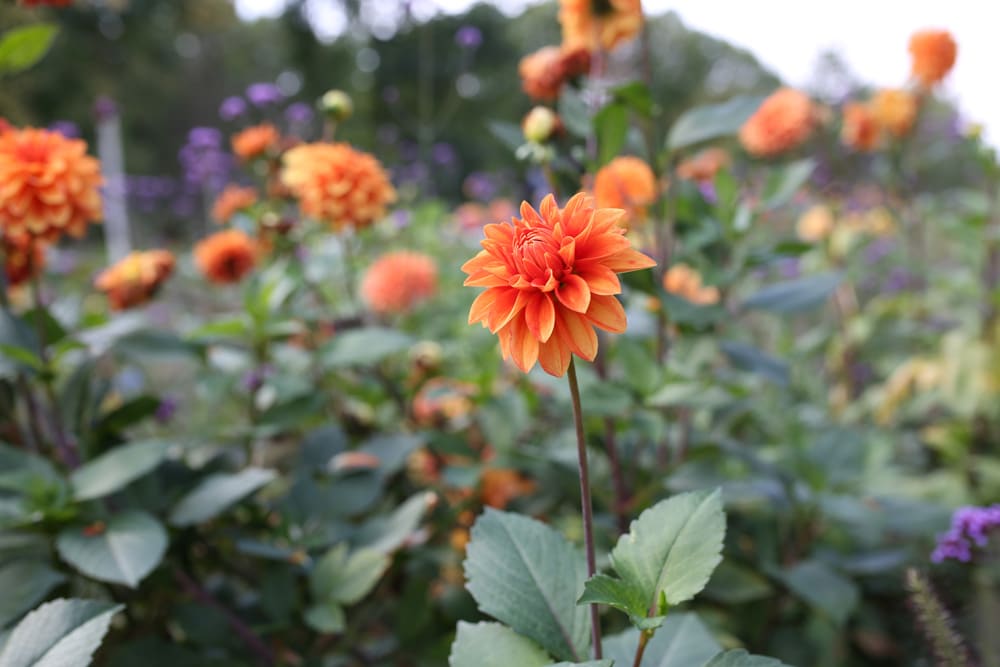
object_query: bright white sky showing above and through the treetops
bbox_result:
[236,0,1000,145]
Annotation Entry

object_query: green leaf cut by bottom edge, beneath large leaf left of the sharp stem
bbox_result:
[448,621,552,667]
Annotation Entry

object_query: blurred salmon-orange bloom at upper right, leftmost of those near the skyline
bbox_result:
[740,88,815,157]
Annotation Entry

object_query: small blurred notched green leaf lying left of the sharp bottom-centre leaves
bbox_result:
[309,544,391,605]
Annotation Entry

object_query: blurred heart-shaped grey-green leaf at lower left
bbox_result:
[56,510,167,588]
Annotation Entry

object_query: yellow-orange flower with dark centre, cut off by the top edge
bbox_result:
[559,0,642,52]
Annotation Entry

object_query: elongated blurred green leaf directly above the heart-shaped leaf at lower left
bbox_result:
[70,440,170,500]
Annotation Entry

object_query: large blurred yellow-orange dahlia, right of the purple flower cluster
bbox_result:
[282,143,396,228]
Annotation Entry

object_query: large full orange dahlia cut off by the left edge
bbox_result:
[0,128,102,241]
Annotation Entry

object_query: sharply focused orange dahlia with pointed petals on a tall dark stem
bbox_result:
[462,193,655,376]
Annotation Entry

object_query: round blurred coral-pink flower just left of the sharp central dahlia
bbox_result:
[361,250,437,314]
